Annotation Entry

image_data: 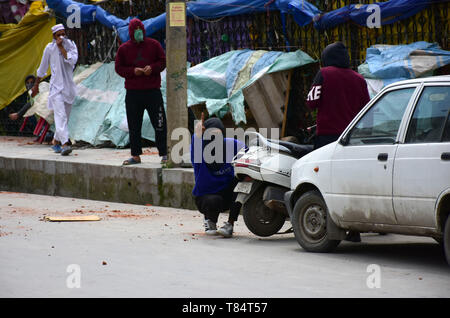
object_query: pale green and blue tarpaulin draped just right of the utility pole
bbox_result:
[187,49,316,125]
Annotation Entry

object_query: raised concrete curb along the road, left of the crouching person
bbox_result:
[0,157,196,209]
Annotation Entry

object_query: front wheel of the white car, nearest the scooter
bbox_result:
[292,190,341,253]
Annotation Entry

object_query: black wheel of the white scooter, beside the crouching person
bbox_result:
[242,187,286,237]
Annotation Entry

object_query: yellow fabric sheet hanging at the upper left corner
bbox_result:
[0,1,55,109]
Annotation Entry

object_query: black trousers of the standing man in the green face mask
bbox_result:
[125,89,167,156]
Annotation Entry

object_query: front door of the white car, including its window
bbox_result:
[327,85,417,224]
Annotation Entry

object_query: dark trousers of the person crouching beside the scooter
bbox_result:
[195,179,242,223]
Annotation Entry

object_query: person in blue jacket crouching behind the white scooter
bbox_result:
[191,114,244,237]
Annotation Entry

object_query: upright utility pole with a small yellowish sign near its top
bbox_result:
[166,0,188,167]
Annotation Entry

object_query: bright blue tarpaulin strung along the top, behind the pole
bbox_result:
[47,0,442,42]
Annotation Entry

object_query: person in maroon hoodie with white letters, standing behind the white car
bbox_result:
[306,42,370,149]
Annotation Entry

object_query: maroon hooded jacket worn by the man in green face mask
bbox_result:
[115,19,166,89]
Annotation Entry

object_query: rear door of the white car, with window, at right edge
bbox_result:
[393,84,450,228]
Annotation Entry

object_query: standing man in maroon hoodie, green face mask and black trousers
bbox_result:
[115,19,167,165]
